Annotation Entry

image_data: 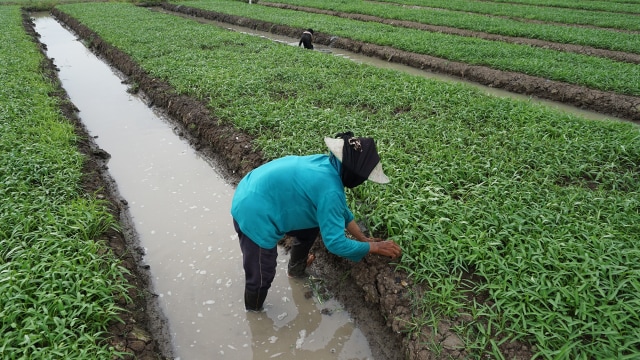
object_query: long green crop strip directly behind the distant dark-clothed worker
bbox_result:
[177,0,640,95]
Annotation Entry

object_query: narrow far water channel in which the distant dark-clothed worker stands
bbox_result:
[159,8,624,121]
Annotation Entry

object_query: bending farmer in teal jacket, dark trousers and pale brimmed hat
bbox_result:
[231,132,402,311]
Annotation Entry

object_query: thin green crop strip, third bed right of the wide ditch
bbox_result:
[262,0,640,54]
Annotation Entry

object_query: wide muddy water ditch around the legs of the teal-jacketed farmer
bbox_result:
[35,16,373,359]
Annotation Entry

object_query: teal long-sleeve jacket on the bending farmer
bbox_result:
[231,155,369,261]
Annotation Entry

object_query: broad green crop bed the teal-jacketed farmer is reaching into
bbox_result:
[59,3,640,359]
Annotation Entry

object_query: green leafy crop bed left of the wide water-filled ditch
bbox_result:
[0,6,127,359]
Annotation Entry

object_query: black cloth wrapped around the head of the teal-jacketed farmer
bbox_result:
[336,132,380,188]
